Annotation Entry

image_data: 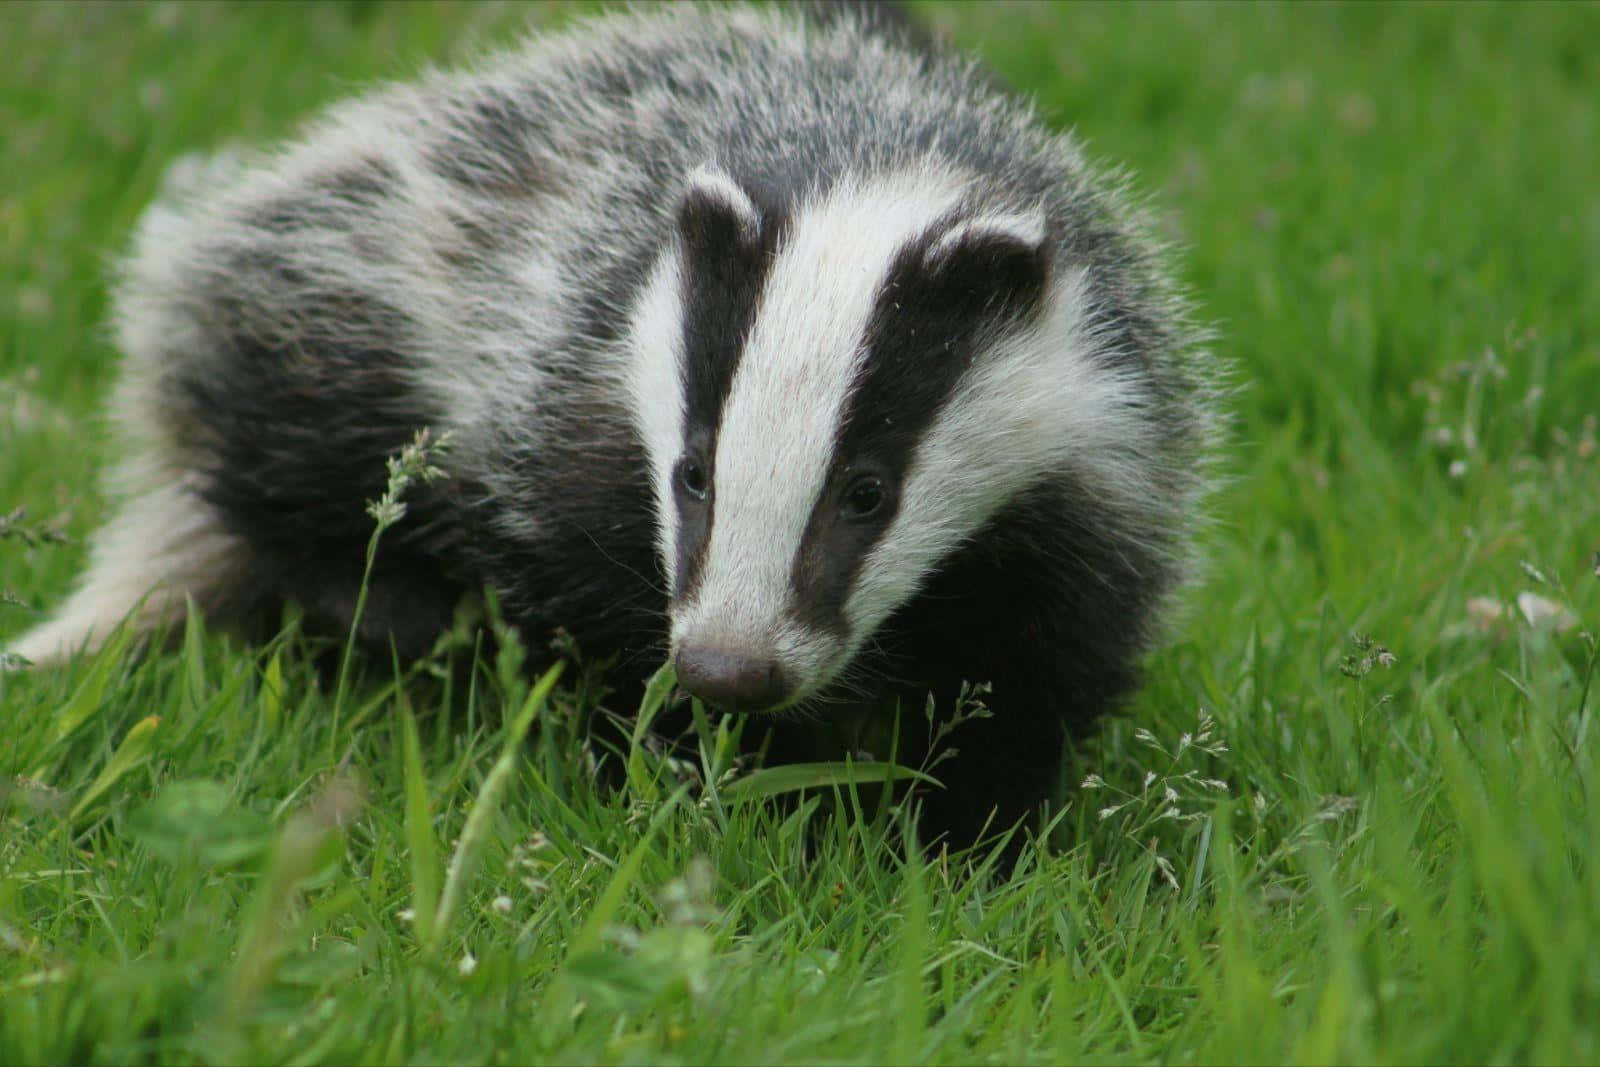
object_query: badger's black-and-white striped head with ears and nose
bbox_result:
[630,168,1126,710]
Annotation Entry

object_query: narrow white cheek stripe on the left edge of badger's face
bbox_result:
[627,251,685,589]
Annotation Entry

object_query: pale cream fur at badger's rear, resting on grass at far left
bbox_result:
[6,485,245,665]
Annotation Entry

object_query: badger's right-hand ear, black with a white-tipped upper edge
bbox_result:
[922,211,1050,321]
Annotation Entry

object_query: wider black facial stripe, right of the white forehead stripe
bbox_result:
[792,212,1048,637]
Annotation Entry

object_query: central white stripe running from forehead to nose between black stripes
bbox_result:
[674,173,962,640]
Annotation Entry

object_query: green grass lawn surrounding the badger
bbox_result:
[0,3,1600,1064]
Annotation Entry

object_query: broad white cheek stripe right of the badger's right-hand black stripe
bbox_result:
[845,270,1147,651]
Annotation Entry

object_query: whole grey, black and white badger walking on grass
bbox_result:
[13,5,1221,837]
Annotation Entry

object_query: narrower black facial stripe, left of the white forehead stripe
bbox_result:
[672,190,787,600]
